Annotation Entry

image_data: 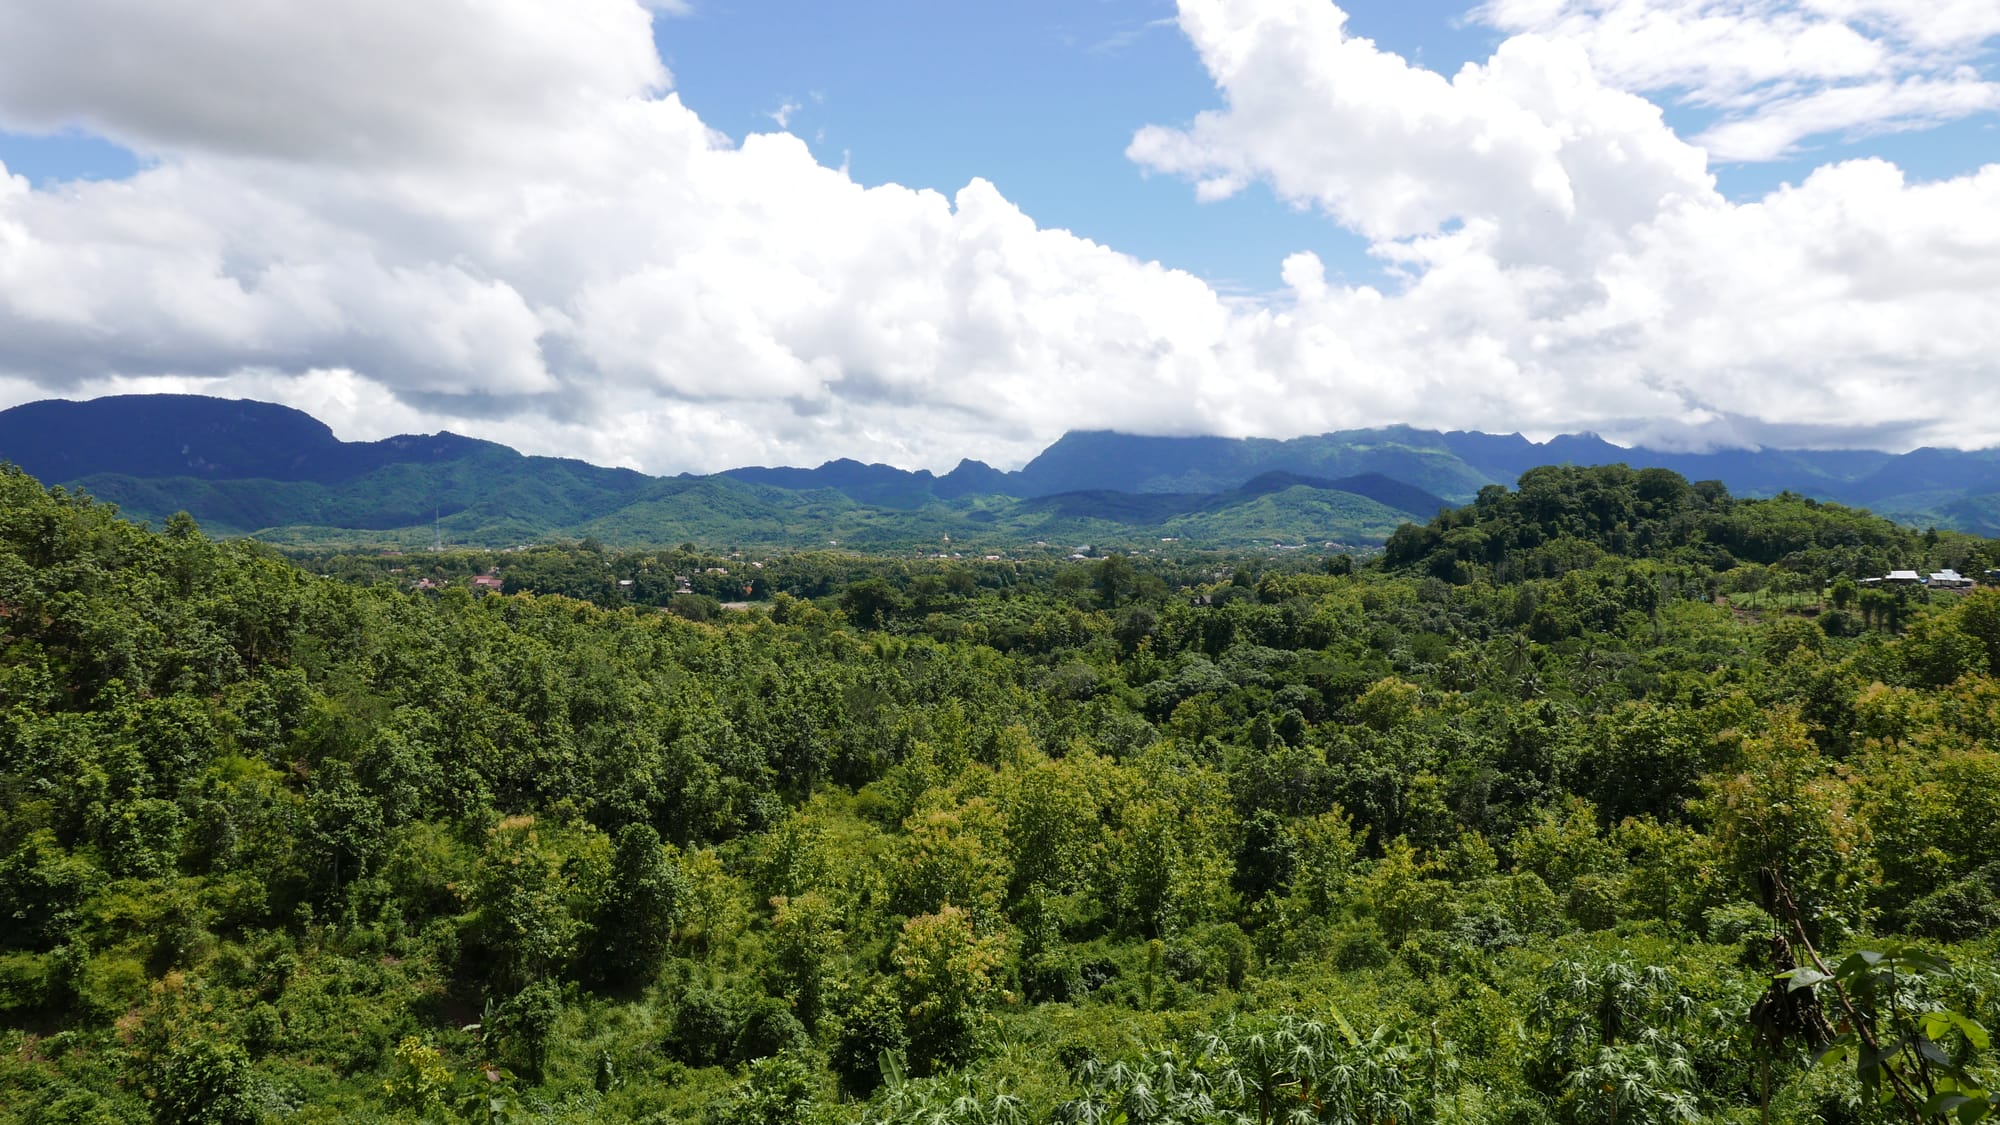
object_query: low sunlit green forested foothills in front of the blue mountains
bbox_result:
[76,464,1438,550]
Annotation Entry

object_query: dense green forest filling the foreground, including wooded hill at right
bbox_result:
[0,466,2000,1125]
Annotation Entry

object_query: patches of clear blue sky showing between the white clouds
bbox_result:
[0,0,2000,292]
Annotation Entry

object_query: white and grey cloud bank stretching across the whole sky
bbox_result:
[0,0,2000,472]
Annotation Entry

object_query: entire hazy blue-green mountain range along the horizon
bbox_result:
[0,394,2000,548]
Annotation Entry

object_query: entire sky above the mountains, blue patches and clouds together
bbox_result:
[0,0,2000,472]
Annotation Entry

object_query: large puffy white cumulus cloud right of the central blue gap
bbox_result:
[1130,0,2000,444]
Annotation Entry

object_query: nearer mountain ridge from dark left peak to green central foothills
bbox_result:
[0,394,1442,548]
